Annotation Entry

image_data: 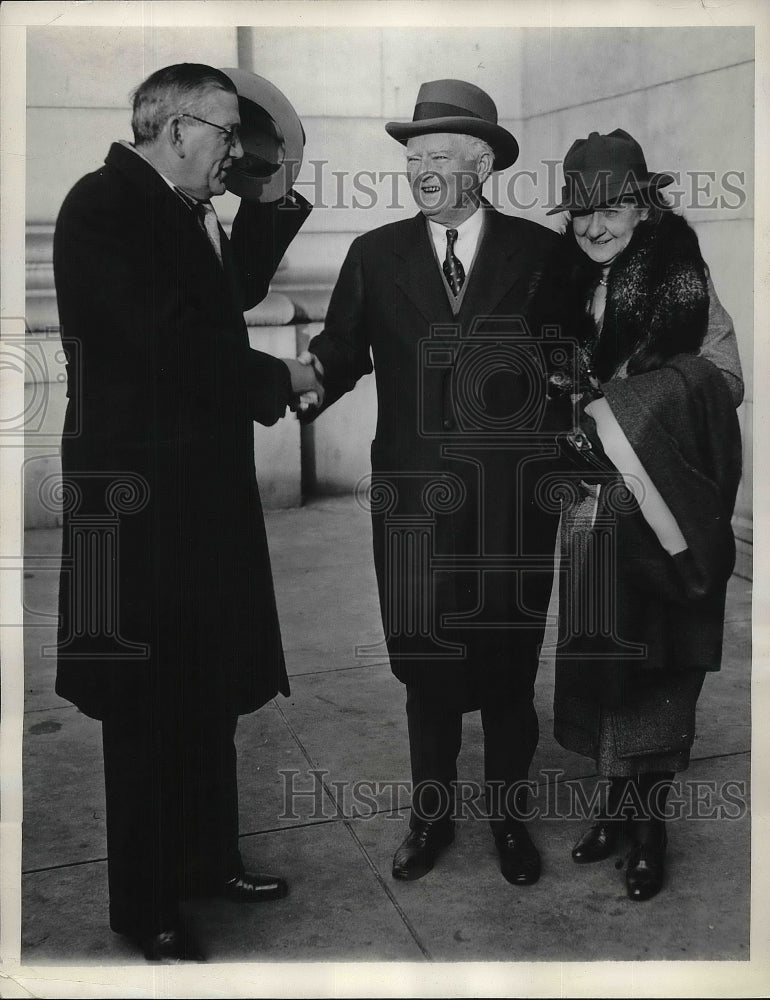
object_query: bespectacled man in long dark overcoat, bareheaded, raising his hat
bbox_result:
[54,63,310,960]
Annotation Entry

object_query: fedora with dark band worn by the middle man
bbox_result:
[385,80,519,170]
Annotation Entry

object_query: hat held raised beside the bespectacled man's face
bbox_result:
[222,68,305,203]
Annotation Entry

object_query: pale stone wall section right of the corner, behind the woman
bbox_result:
[516,28,754,576]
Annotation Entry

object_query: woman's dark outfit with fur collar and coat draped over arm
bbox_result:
[534,213,741,758]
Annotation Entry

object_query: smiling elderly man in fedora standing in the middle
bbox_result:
[300,79,558,885]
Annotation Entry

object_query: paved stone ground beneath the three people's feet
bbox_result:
[22,497,751,964]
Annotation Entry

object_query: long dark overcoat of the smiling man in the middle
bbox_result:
[310,206,557,686]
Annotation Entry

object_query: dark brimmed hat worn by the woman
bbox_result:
[546,128,674,215]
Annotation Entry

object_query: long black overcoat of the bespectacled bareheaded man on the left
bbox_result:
[54,144,309,718]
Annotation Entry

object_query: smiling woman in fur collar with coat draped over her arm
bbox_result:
[537,129,741,900]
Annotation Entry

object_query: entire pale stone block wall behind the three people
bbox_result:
[26,26,754,573]
